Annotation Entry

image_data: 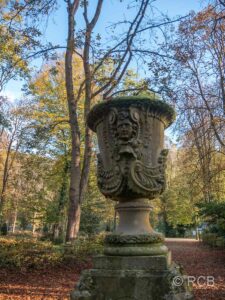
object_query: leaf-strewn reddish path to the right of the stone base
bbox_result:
[166,239,225,300]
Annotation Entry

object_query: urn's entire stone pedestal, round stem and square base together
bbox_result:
[71,199,193,300]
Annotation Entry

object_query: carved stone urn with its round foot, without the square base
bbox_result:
[88,97,175,255]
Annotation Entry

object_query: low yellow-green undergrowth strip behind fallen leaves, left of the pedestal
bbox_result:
[0,234,105,270]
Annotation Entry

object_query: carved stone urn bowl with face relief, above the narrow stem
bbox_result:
[88,97,174,202]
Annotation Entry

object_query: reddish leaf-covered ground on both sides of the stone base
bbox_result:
[0,239,225,300]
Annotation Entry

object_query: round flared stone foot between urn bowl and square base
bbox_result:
[104,199,168,256]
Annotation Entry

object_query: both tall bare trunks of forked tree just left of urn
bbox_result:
[65,0,103,242]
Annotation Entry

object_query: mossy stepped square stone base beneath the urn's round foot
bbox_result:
[71,254,193,300]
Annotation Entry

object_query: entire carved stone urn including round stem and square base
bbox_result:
[71,97,193,300]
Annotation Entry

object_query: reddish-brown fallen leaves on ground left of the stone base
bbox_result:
[0,263,90,300]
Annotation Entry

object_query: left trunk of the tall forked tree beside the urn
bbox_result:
[65,1,81,242]
